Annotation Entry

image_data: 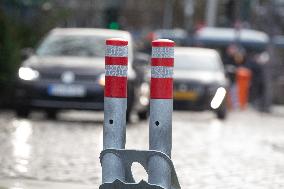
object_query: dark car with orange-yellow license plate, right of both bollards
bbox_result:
[174,47,227,119]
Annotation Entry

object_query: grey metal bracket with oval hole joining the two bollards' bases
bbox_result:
[100,149,180,189]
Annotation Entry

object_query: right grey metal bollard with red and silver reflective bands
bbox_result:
[148,39,175,189]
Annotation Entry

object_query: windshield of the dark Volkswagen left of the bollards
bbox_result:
[36,35,105,57]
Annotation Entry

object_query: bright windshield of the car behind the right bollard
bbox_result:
[175,53,221,71]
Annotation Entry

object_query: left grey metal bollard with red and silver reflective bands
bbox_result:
[101,38,128,183]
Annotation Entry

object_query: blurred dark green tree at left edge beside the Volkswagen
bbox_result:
[0,0,69,104]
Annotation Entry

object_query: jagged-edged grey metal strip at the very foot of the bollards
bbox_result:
[100,180,163,189]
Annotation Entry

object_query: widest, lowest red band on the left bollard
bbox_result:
[105,76,127,98]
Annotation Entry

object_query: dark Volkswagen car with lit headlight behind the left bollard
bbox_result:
[16,28,149,118]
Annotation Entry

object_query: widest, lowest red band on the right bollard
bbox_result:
[151,78,173,99]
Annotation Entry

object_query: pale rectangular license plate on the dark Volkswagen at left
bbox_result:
[47,84,86,97]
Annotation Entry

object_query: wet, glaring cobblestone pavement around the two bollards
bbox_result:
[0,110,284,189]
